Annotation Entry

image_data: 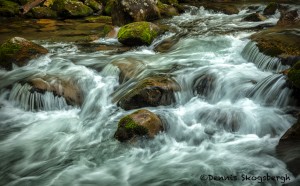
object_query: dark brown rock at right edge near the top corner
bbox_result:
[277,9,300,26]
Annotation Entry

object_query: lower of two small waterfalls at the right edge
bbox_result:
[247,74,292,107]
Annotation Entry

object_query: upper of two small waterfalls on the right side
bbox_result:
[242,41,288,72]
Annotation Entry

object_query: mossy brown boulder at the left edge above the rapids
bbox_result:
[0,37,48,70]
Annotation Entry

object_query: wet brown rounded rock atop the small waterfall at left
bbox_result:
[27,76,82,106]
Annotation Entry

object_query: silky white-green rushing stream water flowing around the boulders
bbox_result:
[0,5,299,186]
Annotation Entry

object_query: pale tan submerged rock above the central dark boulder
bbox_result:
[111,58,145,84]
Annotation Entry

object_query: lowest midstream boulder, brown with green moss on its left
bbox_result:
[114,109,163,142]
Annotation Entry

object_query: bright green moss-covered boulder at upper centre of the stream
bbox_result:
[118,22,160,46]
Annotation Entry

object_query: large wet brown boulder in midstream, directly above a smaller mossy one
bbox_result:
[118,76,180,110]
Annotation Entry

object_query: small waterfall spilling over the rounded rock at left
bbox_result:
[9,83,68,111]
